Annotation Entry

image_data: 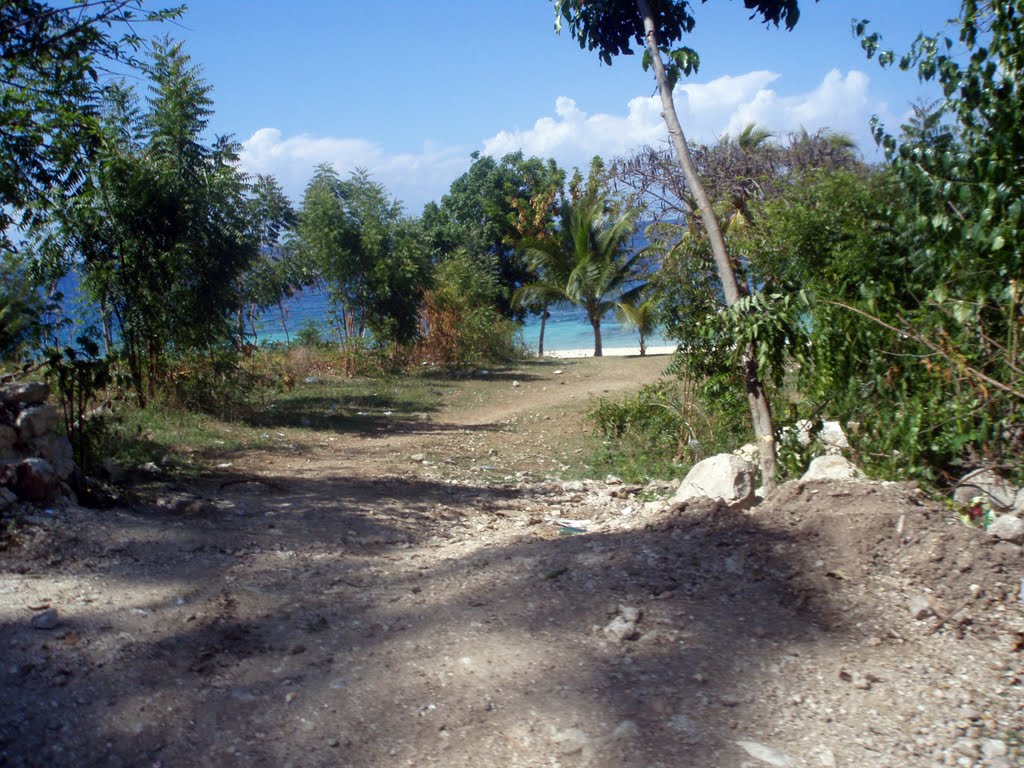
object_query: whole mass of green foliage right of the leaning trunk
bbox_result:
[724,0,1024,480]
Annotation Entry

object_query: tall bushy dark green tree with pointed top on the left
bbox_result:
[36,41,256,403]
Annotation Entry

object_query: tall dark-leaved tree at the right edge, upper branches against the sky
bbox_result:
[811,0,1024,473]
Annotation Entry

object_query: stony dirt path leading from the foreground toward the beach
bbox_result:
[0,358,1024,768]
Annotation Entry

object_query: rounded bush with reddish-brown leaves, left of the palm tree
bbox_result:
[420,251,518,365]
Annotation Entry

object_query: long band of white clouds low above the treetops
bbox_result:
[242,70,899,213]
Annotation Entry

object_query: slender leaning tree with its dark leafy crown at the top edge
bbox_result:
[554,0,799,493]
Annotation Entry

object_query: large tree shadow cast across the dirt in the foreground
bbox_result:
[0,478,833,768]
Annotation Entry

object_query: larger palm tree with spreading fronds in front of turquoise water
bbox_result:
[514,194,643,357]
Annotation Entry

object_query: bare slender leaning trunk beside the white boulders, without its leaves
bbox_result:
[637,0,775,496]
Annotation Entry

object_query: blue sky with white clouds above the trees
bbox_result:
[162,0,959,214]
